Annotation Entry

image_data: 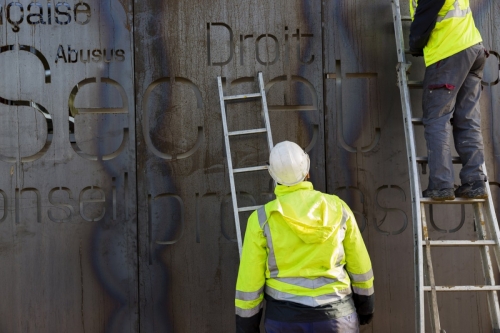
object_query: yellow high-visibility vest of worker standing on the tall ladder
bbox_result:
[410,0,482,66]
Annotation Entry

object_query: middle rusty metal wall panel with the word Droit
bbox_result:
[135,0,325,332]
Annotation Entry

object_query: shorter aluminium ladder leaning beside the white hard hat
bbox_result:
[217,72,273,257]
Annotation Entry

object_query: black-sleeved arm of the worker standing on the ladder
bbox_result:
[410,0,445,56]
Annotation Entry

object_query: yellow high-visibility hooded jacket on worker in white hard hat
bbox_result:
[235,181,373,317]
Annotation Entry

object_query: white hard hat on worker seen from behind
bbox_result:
[269,141,309,186]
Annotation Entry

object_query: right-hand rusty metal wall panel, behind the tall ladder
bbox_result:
[323,0,500,332]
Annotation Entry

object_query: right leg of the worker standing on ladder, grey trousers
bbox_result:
[453,45,486,184]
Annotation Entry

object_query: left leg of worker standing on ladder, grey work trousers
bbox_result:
[422,46,473,189]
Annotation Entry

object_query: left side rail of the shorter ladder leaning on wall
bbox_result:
[217,76,242,258]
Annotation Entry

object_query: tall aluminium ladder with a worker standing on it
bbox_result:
[392,0,500,333]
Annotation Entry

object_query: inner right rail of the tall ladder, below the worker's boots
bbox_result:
[473,203,500,330]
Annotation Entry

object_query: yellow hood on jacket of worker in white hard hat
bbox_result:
[268,181,342,244]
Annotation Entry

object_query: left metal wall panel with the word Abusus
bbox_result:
[0,0,138,333]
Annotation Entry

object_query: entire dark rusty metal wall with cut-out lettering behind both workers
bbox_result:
[0,0,500,333]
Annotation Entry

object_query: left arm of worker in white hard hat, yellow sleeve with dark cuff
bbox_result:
[235,212,267,333]
